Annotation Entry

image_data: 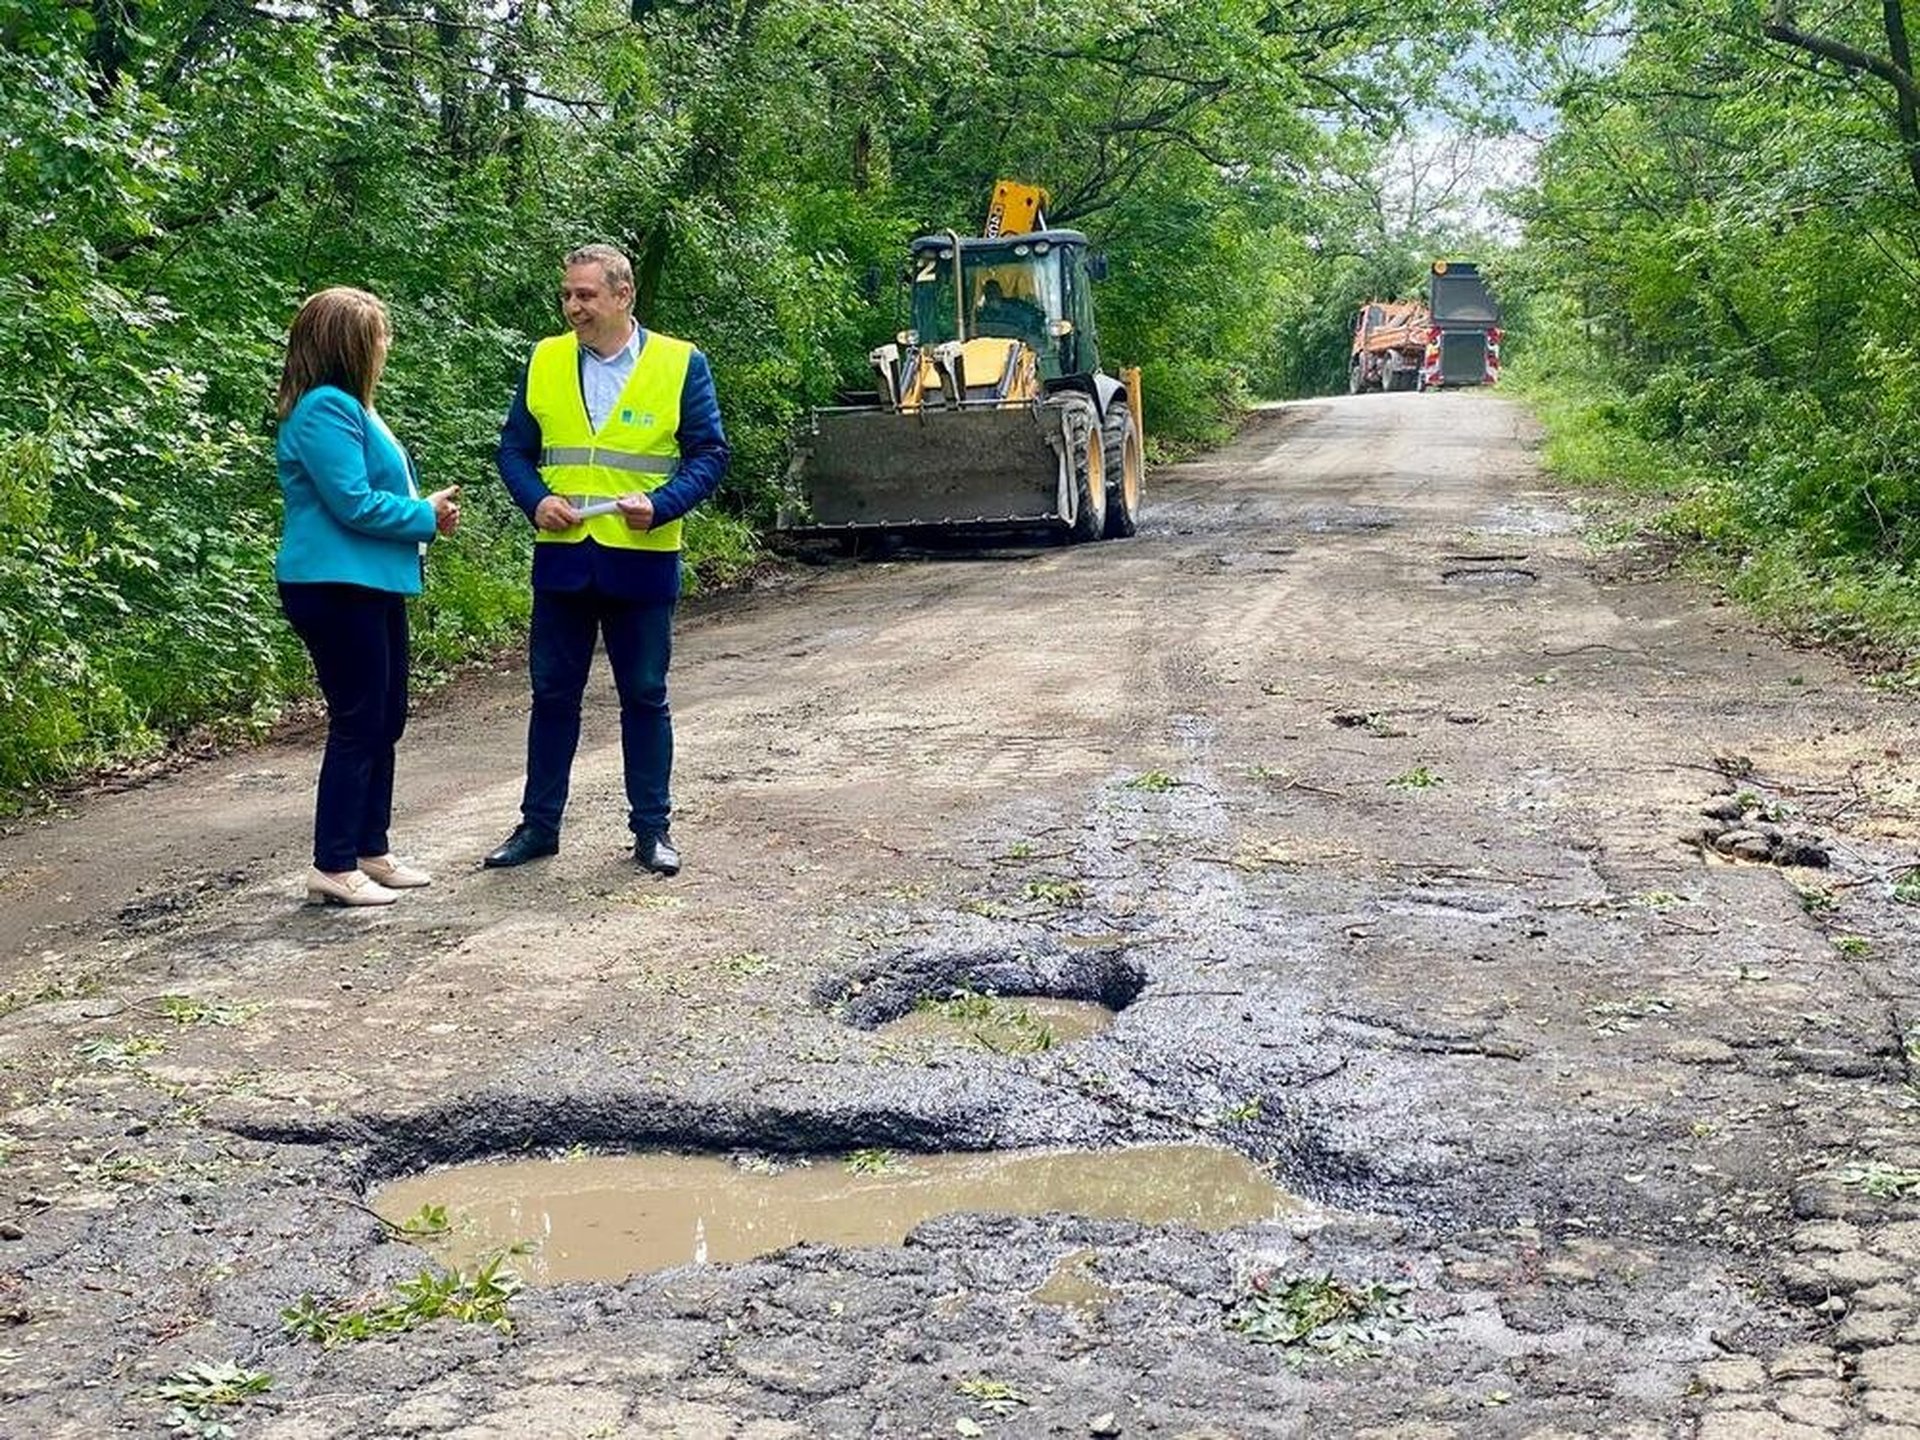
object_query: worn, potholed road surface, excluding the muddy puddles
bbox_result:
[0,394,1920,1440]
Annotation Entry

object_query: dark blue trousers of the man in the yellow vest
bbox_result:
[520,589,674,835]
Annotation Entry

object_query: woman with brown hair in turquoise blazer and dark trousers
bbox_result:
[273,286,461,904]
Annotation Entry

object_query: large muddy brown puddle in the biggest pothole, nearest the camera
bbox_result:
[374,1146,1298,1284]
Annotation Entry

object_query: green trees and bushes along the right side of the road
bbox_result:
[1515,0,1920,664]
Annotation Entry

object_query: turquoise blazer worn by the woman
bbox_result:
[273,386,436,595]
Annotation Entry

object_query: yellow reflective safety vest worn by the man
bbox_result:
[526,330,693,551]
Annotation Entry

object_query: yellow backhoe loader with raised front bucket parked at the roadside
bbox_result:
[780,180,1146,540]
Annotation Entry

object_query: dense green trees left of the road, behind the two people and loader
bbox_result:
[0,0,1528,799]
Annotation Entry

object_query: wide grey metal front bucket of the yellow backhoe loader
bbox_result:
[783,405,1075,534]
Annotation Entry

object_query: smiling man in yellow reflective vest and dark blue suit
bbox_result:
[486,246,730,876]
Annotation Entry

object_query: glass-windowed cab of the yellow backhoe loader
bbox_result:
[908,230,1100,380]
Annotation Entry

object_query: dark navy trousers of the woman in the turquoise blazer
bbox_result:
[280,586,407,872]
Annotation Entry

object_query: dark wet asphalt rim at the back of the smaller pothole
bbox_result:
[814,939,1146,1029]
